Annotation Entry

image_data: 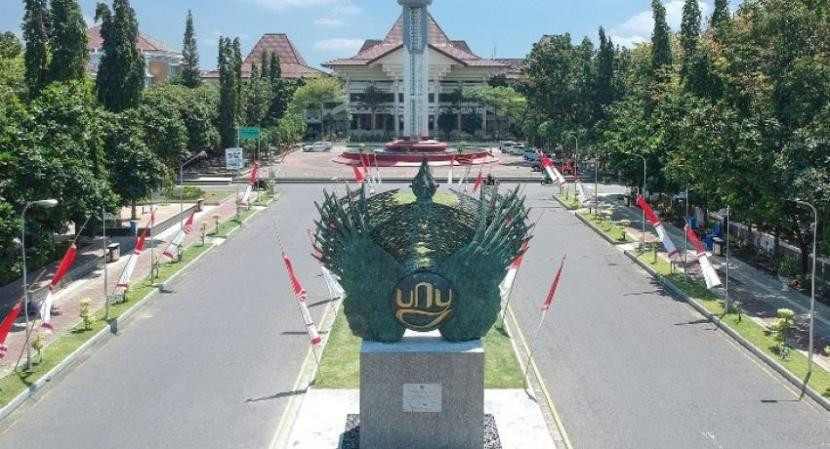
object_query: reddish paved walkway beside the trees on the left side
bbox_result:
[0,196,244,378]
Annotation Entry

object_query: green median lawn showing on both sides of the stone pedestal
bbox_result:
[314,309,525,390]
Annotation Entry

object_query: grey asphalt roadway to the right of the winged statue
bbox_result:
[512,186,830,449]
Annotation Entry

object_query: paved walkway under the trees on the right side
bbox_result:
[602,196,830,370]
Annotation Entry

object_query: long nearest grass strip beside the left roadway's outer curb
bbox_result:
[0,244,209,407]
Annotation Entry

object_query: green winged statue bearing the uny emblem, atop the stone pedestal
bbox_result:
[315,161,531,342]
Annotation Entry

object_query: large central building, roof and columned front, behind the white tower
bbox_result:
[323,15,512,137]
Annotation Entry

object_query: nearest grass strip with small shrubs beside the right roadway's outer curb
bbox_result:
[638,252,830,398]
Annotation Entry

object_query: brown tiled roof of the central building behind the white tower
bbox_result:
[323,14,505,67]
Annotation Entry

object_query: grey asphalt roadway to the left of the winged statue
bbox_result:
[0,186,342,449]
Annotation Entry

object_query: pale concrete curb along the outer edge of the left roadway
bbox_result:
[0,201,273,421]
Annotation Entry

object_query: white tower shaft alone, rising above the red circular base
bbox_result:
[398,0,432,139]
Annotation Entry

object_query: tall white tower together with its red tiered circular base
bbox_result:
[334,0,497,167]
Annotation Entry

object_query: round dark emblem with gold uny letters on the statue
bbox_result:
[392,272,458,332]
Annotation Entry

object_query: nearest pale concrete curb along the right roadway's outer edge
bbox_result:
[623,250,830,411]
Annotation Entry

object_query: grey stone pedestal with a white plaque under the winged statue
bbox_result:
[360,332,484,449]
